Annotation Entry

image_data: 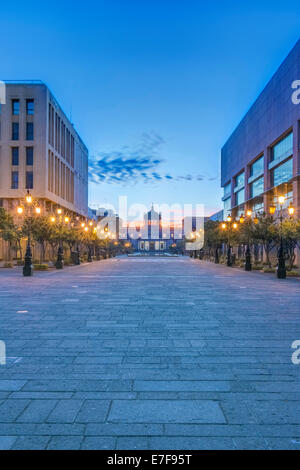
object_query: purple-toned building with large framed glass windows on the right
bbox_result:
[221,41,300,217]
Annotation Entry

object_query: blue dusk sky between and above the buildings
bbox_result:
[0,0,300,214]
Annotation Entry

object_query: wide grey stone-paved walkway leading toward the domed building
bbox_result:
[0,258,300,449]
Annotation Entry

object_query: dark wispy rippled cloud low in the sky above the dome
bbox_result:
[89,133,215,185]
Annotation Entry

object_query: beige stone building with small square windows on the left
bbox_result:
[0,81,88,217]
